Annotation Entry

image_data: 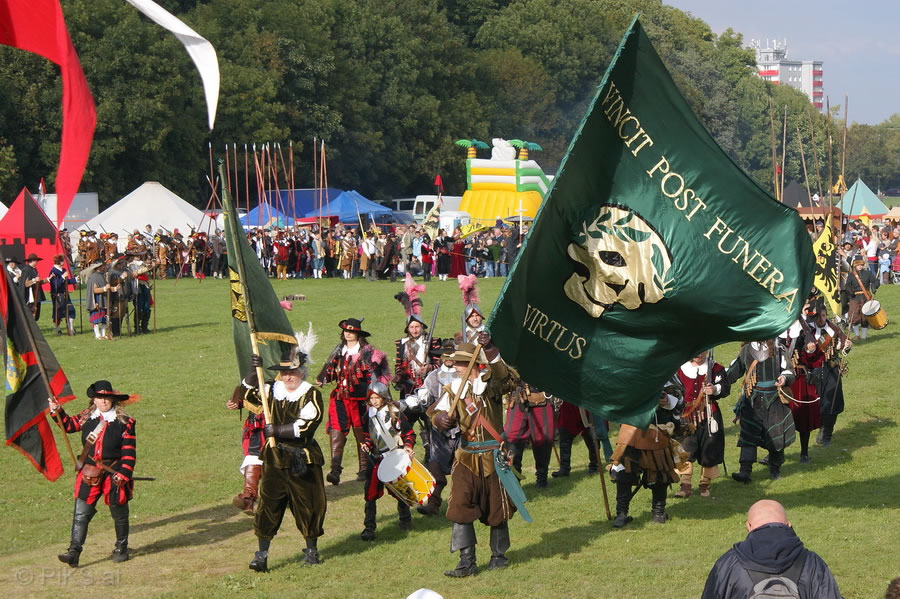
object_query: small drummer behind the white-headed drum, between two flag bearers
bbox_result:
[359,382,416,541]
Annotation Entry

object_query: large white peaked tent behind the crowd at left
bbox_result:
[74,181,203,250]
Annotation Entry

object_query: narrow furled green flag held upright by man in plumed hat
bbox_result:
[219,168,297,377]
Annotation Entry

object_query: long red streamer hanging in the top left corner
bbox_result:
[0,0,97,226]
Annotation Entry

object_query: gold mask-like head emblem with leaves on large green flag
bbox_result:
[565,206,672,318]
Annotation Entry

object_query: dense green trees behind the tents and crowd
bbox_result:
[0,0,900,207]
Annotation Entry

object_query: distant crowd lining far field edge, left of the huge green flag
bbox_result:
[74,223,528,280]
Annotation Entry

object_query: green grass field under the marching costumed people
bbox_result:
[0,279,900,599]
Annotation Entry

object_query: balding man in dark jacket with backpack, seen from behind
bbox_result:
[702,499,841,599]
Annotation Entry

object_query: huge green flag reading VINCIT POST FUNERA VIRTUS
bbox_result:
[489,18,813,426]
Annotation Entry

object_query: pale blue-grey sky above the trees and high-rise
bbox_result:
[663,0,900,125]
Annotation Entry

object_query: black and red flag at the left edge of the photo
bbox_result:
[0,253,75,481]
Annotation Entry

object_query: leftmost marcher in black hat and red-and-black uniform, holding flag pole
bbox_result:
[50,381,137,568]
